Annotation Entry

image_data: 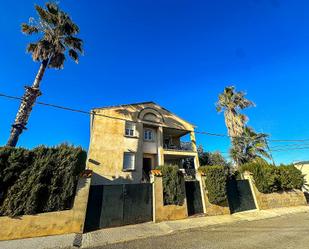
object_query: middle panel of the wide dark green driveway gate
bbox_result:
[100,185,124,227]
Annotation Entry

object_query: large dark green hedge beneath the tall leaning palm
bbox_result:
[0,144,87,216]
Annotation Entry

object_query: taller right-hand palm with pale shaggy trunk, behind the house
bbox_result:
[216,86,254,140]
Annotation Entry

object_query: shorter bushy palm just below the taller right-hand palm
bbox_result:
[230,126,271,166]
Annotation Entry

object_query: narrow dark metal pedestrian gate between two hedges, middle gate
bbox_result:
[185,181,203,216]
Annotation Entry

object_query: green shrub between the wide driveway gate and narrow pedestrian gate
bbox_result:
[158,165,185,206]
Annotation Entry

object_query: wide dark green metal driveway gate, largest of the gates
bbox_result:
[84,183,152,232]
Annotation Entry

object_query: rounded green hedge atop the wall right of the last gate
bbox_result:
[241,160,304,194]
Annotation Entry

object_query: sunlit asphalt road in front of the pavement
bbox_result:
[92,213,309,249]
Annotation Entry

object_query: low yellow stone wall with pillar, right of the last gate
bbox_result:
[244,172,307,210]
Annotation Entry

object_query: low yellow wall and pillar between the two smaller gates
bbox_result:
[201,176,231,216]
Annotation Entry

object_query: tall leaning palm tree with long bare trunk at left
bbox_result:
[7,3,83,147]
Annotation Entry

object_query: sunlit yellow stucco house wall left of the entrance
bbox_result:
[87,116,141,184]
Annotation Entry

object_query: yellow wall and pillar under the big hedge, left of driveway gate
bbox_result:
[0,178,90,240]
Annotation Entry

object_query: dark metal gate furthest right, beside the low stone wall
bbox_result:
[227,179,256,213]
